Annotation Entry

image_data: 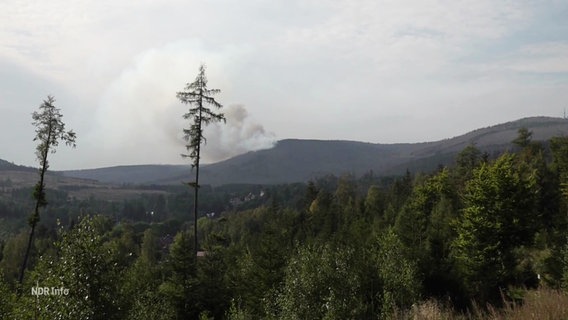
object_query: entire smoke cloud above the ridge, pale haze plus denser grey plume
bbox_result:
[86,42,274,167]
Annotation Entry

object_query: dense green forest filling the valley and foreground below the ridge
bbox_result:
[0,129,568,319]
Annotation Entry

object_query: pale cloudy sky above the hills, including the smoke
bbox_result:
[0,0,568,170]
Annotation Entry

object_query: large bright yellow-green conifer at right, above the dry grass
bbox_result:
[453,154,538,300]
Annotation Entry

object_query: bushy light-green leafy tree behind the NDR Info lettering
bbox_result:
[13,216,121,319]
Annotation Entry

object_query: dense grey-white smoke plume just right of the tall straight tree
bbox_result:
[202,105,276,162]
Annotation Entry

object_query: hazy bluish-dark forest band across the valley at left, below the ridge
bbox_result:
[0,184,272,234]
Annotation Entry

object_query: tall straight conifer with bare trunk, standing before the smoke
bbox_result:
[176,65,226,254]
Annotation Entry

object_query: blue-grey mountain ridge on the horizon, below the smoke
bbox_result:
[56,117,568,185]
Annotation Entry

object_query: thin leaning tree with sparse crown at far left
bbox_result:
[18,96,76,285]
